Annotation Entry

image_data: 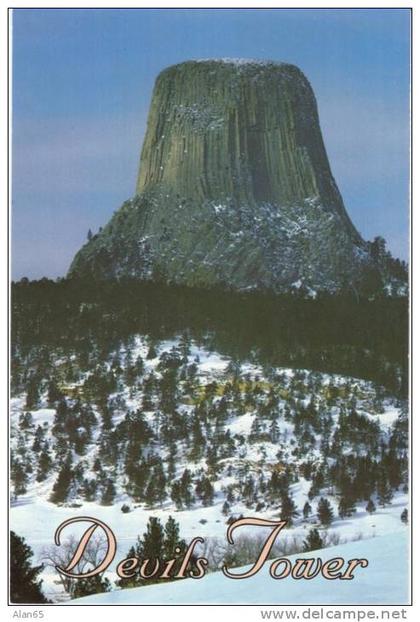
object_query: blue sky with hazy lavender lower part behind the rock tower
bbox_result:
[12,9,410,278]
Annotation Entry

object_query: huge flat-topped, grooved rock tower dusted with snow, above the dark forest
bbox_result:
[69,60,367,291]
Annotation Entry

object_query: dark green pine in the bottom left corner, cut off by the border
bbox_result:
[10,531,49,605]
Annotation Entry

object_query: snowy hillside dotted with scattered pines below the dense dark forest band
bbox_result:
[11,335,408,601]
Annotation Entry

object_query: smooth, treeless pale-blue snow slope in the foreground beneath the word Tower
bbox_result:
[73,530,409,605]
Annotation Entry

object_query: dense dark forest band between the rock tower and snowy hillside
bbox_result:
[12,279,408,397]
